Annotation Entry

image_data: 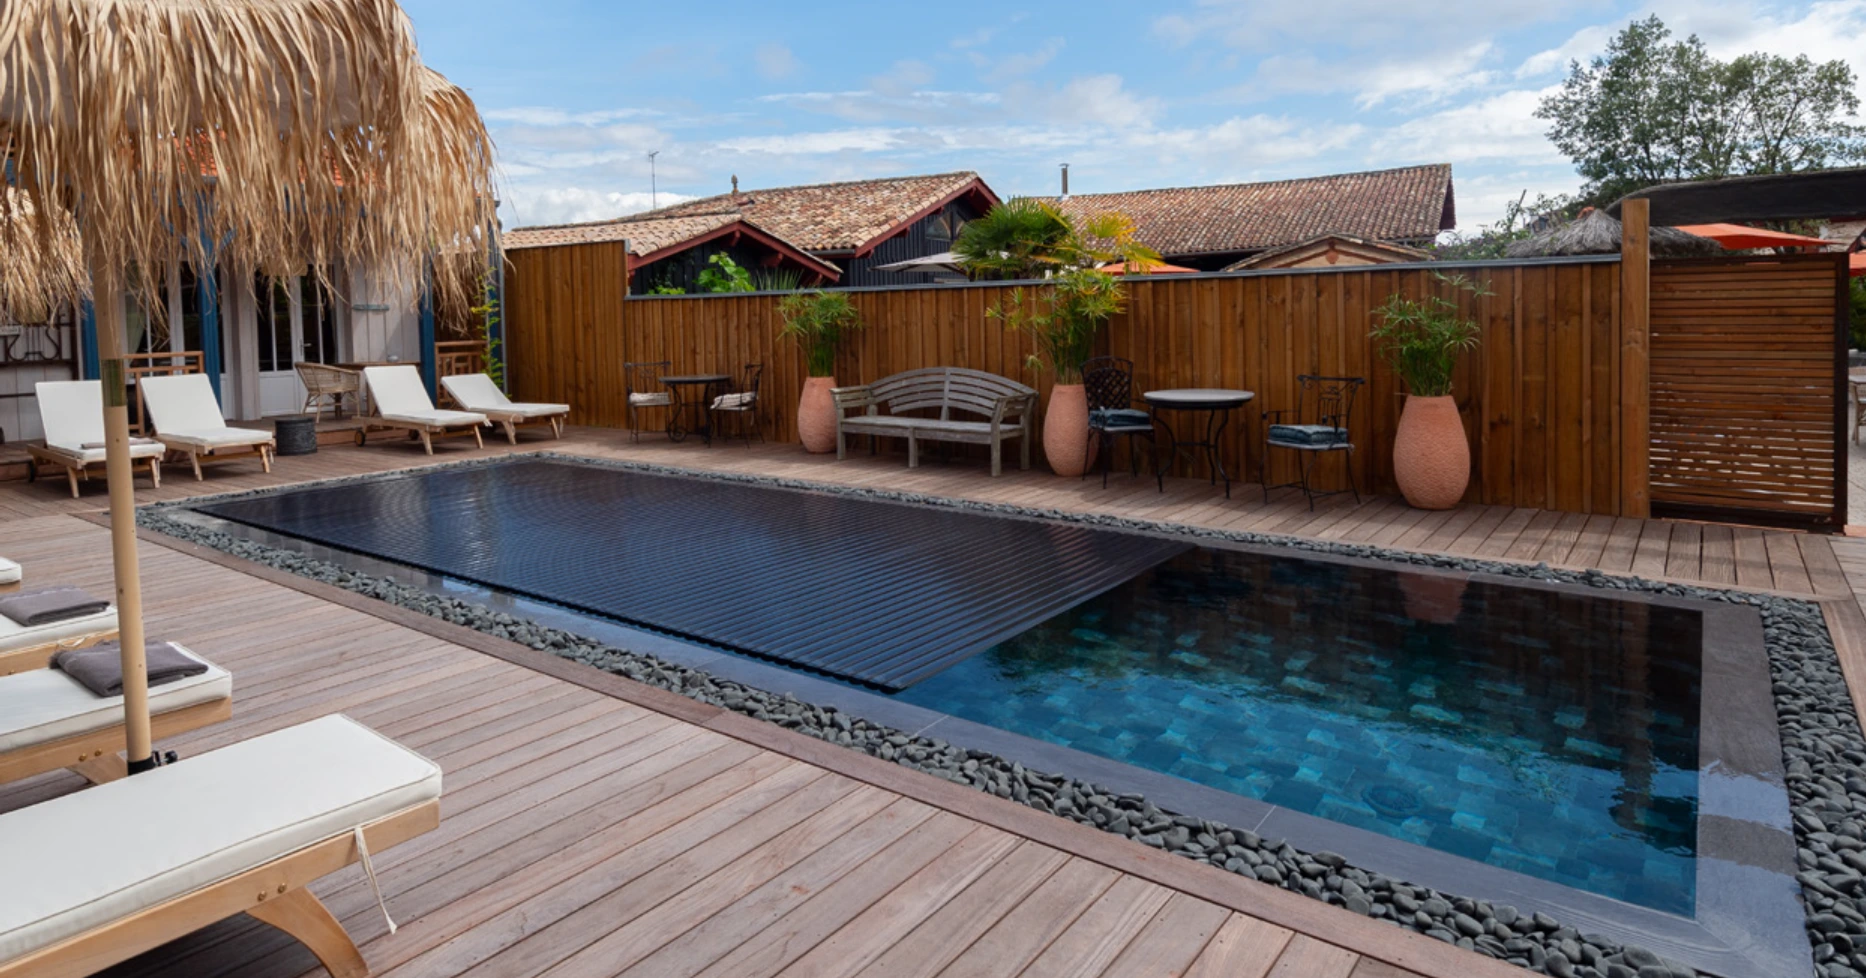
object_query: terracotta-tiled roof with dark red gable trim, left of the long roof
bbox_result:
[638,170,996,252]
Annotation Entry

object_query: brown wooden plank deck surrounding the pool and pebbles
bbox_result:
[0,431,1866,978]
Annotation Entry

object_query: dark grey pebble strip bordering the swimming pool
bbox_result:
[138,452,1843,978]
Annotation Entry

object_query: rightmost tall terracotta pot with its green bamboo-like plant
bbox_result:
[1370,274,1489,510]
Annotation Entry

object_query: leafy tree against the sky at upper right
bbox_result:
[1536,17,1866,203]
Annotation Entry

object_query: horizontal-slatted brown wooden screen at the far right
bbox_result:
[1651,254,1847,526]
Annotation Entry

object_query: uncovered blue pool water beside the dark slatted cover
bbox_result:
[896,549,1704,915]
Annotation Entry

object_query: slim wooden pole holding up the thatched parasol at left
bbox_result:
[91,258,155,775]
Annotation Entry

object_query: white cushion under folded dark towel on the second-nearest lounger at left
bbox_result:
[0,646,233,752]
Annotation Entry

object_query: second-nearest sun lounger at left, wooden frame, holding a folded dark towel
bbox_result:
[0,646,233,787]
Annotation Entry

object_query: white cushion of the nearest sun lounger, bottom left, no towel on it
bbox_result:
[0,715,440,961]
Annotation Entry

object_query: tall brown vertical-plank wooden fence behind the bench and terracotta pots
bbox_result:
[506,245,1832,515]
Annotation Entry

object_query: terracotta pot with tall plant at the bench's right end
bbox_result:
[989,269,1127,476]
